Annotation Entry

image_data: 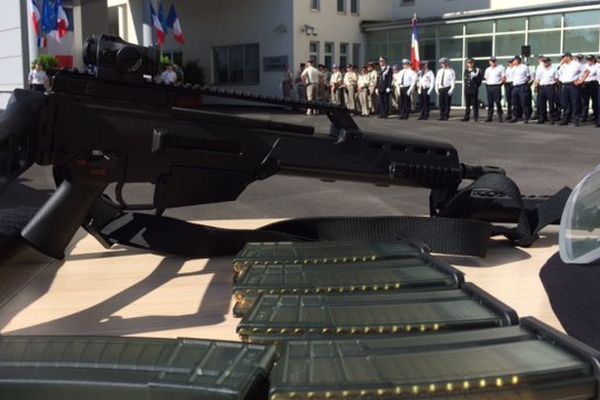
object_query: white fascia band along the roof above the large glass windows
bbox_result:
[394,0,592,19]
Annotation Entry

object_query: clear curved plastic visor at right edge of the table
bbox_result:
[559,165,600,264]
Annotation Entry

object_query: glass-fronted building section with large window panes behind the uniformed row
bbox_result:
[362,0,600,105]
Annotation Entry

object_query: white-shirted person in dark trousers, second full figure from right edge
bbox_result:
[559,53,589,127]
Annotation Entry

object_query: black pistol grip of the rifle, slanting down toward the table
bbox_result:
[21,180,106,260]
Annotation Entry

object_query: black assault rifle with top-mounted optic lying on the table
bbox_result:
[0,35,568,258]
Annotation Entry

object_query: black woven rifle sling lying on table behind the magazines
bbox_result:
[88,174,570,258]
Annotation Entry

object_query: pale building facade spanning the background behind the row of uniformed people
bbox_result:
[0,0,600,108]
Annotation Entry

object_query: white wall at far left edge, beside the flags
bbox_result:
[0,0,28,109]
